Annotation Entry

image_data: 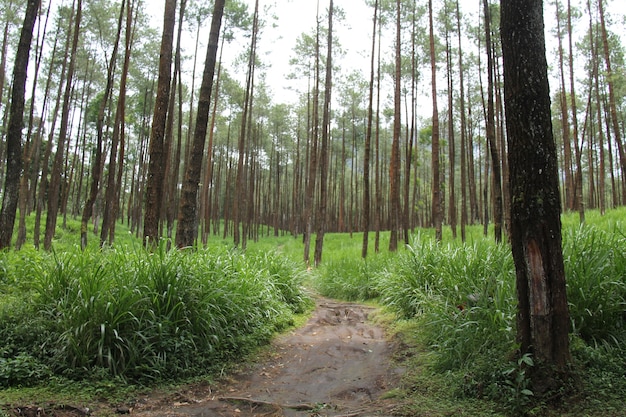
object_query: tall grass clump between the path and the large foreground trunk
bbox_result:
[380,237,515,370]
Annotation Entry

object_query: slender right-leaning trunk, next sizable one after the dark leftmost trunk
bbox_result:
[43,0,83,250]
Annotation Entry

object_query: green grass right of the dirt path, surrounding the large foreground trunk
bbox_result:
[315,209,626,416]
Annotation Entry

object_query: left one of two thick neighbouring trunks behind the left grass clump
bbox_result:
[143,0,176,247]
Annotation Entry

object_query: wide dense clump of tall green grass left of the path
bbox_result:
[0,244,310,386]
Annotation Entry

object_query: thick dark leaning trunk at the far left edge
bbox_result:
[0,0,41,249]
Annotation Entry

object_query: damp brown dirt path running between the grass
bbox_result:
[129,299,400,417]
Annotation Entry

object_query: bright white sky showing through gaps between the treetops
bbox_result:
[150,0,626,109]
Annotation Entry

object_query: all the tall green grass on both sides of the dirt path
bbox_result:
[0,209,626,416]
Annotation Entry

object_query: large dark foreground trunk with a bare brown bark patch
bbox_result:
[501,0,570,394]
